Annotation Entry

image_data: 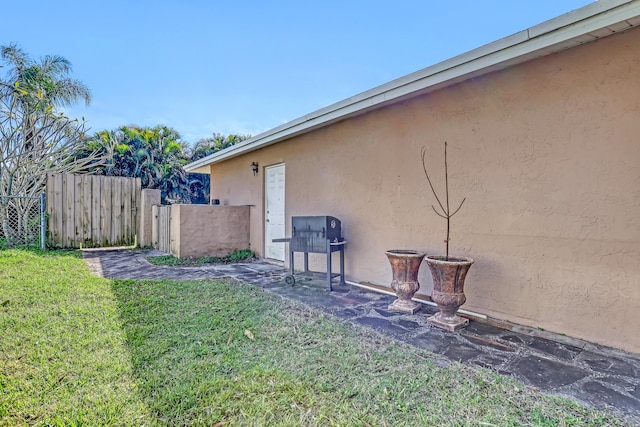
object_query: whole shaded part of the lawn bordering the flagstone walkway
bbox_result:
[113,280,623,426]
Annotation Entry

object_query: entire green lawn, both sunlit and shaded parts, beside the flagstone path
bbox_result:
[0,250,623,426]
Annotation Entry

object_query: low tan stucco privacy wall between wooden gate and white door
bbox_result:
[171,205,249,258]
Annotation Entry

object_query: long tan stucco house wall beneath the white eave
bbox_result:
[211,30,640,352]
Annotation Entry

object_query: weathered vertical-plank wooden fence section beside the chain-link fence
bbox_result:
[47,174,141,248]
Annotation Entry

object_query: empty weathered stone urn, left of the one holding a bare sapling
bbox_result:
[386,249,425,314]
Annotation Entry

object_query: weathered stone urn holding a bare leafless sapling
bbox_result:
[427,256,473,331]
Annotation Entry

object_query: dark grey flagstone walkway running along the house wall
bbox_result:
[83,250,640,425]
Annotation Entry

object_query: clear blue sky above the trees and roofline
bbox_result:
[5,0,592,142]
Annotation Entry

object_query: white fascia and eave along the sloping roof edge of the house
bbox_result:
[185,0,640,172]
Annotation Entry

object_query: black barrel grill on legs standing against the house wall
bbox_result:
[274,216,347,290]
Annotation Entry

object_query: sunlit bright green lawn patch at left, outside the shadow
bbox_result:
[0,249,155,426]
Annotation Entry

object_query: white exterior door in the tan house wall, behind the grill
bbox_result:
[264,163,286,261]
